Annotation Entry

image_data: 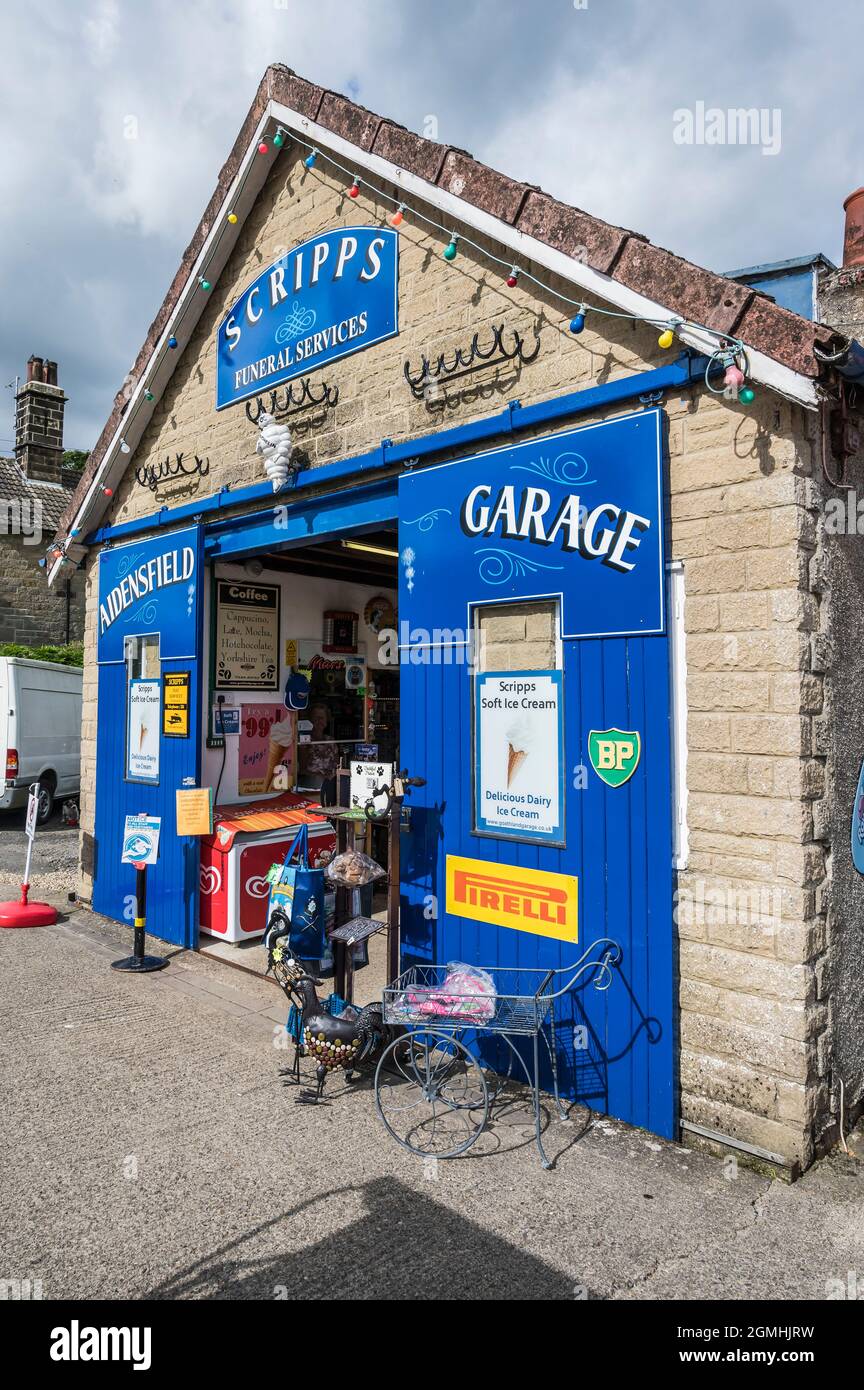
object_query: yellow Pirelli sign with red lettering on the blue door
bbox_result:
[447,855,579,941]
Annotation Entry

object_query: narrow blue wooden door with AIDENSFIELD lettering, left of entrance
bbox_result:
[93,528,201,947]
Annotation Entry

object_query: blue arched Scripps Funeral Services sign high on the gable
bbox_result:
[217,227,399,410]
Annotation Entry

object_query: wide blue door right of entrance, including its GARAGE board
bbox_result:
[399,410,676,1136]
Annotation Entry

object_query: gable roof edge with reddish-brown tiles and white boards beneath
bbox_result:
[51,64,832,573]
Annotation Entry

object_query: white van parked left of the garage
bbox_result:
[0,656,83,821]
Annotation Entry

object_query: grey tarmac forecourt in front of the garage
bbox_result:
[0,906,864,1295]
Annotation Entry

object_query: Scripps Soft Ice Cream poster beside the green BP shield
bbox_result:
[474,671,564,842]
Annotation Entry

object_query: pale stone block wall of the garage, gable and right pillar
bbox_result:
[82,143,828,1165]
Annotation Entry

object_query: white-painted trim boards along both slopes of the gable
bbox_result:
[49,99,818,584]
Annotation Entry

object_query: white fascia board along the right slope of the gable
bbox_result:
[271,101,818,409]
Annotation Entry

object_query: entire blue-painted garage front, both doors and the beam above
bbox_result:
[93,403,676,1136]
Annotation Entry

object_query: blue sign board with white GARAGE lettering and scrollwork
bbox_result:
[399,410,665,637]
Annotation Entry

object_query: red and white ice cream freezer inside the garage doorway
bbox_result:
[199,792,336,941]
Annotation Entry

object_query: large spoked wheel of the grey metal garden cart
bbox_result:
[375,1030,489,1158]
